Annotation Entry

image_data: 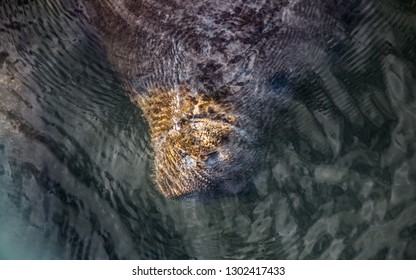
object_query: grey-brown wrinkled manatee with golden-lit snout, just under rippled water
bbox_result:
[79,0,358,198]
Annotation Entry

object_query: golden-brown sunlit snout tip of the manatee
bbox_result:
[132,87,255,199]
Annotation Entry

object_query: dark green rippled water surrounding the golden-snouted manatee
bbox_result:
[0,0,416,259]
